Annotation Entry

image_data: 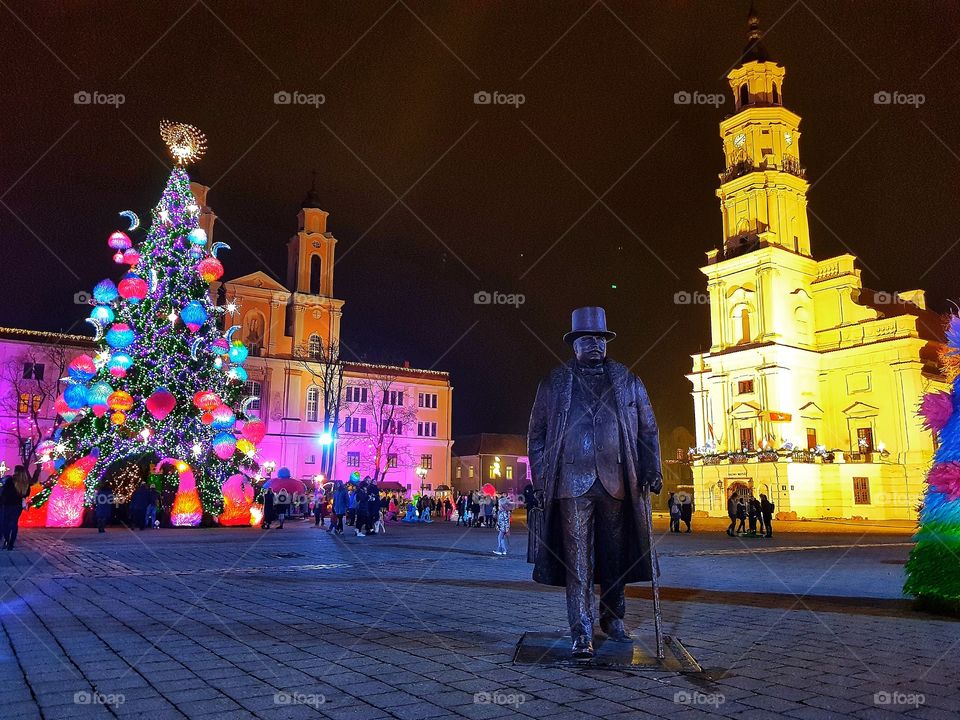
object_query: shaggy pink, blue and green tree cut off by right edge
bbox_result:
[904,315,960,614]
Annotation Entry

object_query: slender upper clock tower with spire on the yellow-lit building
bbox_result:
[717,5,810,257]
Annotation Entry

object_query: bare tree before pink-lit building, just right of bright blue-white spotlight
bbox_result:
[341,372,417,482]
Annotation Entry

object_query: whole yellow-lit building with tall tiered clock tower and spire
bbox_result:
[687,9,946,519]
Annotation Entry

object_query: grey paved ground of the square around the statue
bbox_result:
[0,522,960,720]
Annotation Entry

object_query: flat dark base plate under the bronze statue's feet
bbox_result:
[513,631,702,673]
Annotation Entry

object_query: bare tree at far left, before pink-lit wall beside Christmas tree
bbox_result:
[0,345,69,477]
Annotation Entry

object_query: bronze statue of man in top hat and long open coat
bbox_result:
[527,307,663,659]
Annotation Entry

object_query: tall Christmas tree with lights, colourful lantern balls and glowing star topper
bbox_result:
[32,121,265,527]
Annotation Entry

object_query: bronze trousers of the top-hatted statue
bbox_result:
[558,481,626,637]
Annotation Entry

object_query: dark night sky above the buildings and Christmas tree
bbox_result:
[0,0,960,434]
